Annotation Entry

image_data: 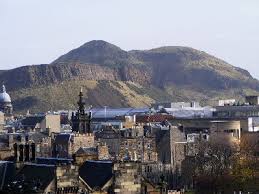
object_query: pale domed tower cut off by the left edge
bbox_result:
[0,85,13,118]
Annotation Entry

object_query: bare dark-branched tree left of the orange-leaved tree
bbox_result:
[182,141,233,193]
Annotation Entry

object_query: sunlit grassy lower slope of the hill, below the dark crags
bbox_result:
[10,80,256,113]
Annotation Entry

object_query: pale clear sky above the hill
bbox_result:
[0,0,259,79]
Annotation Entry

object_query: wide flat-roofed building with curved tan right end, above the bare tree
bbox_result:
[171,118,244,155]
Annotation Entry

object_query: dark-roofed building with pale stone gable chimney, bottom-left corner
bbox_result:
[3,163,79,194]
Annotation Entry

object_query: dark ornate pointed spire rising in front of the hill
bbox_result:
[71,88,91,134]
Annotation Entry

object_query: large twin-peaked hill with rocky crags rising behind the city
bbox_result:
[0,41,259,112]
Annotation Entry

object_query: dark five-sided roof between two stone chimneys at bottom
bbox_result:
[79,161,113,189]
